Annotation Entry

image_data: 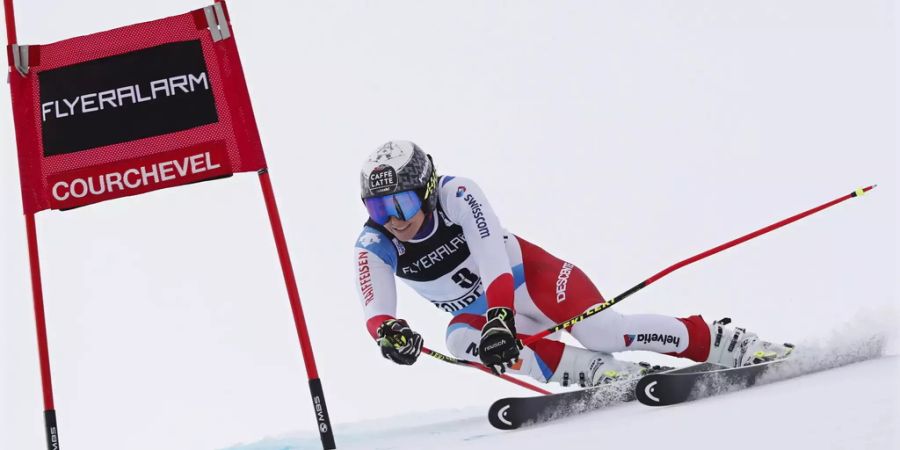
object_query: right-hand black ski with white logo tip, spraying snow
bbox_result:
[635,359,787,406]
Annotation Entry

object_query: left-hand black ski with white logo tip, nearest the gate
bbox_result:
[488,380,637,430]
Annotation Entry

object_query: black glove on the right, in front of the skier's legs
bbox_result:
[478,308,522,375]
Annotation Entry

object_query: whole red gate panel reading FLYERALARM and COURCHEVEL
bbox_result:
[7,4,266,214]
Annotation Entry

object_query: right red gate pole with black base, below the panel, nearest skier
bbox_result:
[259,169,337,450]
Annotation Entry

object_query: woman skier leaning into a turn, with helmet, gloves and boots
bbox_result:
[354,141,790,386]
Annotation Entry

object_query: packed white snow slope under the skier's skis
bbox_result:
[226,329,900,450]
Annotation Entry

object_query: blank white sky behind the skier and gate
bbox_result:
[0,0,898,450]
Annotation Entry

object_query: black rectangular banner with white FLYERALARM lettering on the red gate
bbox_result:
[38,40,219,157]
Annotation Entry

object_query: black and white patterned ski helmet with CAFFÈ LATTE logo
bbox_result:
[360,141,437,213]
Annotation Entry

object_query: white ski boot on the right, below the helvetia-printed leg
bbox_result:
[706,317,794,367]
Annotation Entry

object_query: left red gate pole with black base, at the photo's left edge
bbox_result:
[3,0,59,450]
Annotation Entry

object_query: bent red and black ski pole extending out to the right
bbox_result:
[522,184,878,345]
